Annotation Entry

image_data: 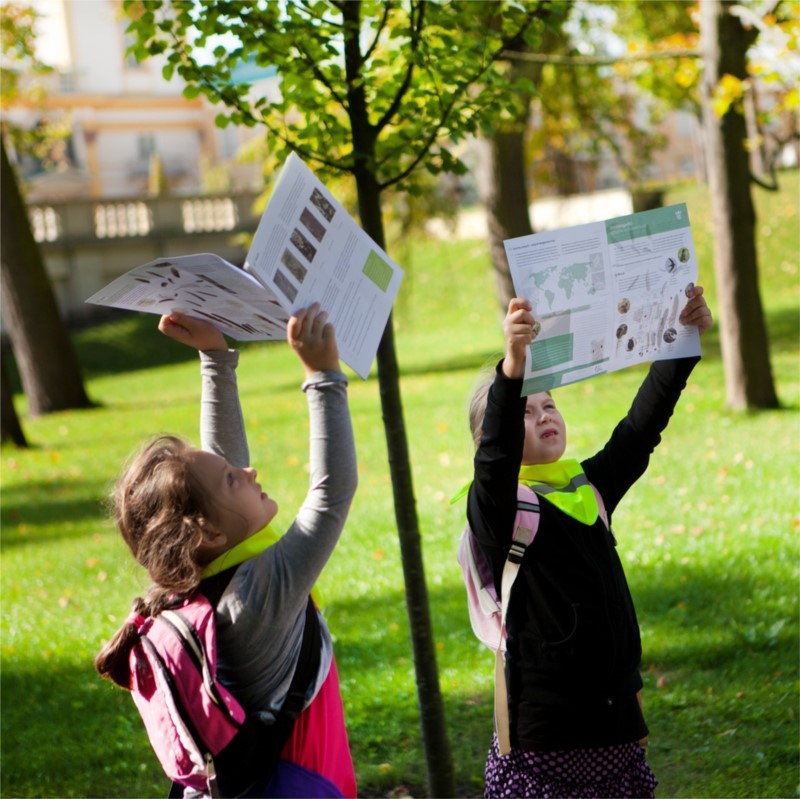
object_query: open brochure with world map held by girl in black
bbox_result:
[504,204,700,395]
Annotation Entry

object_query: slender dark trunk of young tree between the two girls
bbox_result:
[342,2,455,797]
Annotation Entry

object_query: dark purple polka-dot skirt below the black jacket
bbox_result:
[484,735,658,799]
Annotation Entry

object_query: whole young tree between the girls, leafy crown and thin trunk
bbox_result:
[124,0,552,796]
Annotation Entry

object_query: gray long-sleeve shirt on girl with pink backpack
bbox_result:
[200,350,357,720]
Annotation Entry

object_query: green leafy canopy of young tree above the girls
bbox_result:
[125,0,561,190]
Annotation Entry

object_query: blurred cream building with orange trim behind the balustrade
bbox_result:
[8,0,263,202]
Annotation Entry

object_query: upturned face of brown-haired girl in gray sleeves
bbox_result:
[191,450,278,555]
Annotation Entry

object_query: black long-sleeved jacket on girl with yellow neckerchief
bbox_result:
[467,358,699,751]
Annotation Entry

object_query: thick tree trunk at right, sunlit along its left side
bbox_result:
[700,0,778,409]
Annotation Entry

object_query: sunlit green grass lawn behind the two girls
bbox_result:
[0,173,800,797]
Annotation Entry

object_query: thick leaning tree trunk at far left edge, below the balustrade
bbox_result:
[0,134,91,416]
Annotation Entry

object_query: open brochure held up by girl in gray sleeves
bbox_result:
[86,153,403,378]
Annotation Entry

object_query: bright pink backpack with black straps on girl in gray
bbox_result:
[128,588,321,797]
